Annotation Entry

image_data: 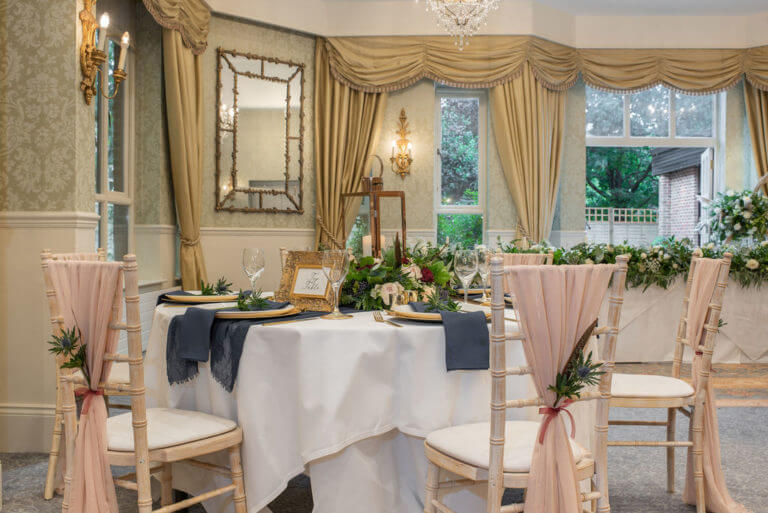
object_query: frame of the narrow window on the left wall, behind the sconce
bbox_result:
[94,39,136,259]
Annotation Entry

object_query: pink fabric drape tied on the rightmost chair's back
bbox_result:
[683,258,748,513]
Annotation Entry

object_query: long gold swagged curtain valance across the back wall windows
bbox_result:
[325,36,768,94]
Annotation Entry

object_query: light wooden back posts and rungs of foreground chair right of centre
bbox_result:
[487,255,629,513]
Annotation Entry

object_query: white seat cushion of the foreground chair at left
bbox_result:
[107,408,237,452]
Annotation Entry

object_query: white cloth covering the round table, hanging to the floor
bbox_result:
[145,306,595,513]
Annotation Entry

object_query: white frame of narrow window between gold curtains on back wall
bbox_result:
[433,86,488,243]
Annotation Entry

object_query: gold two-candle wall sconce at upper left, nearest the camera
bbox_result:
[80,0,130,105]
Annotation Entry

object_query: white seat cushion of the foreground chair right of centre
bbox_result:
[427,421,588,472]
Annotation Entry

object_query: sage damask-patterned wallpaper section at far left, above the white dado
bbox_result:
[0,0,94,211]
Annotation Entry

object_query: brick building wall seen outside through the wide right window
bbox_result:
[659,166,699,244]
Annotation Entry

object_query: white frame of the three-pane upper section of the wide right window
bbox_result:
[584,85,725,148]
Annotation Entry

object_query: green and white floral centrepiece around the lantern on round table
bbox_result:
[340,241,453,310]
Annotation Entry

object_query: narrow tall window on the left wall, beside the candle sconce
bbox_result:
[95,38,133,260]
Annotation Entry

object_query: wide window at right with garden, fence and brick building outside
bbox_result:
[585,86,717,243]
